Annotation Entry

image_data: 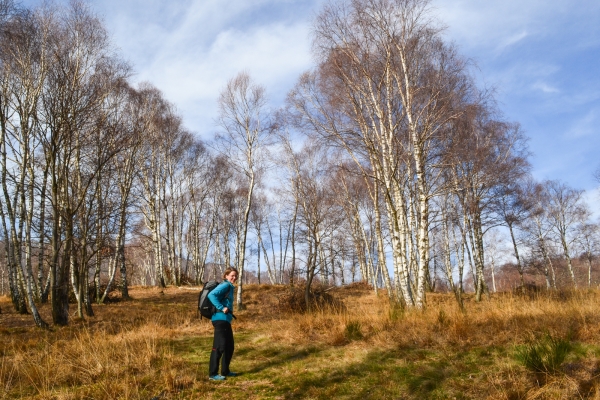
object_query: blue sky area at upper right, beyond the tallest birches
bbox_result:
[436,0,600,200]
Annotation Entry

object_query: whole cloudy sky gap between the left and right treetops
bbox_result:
[89,0,322,136]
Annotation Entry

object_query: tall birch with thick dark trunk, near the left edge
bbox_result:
[42,2,129,325]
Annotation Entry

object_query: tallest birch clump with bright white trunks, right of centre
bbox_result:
[290,0,482,307]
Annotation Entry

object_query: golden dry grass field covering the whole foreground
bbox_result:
[0,285,600,400]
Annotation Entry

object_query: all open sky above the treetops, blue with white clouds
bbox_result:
[23,0,600,215]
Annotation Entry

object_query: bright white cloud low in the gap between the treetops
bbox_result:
[144,24,310,141]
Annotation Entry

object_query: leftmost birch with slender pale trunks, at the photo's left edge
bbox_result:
[0,1,49,327]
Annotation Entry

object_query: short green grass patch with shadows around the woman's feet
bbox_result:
[166,333,507,399]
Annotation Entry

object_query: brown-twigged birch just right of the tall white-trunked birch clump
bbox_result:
[445,102,529,301]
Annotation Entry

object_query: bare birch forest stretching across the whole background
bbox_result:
[0,0,600,327]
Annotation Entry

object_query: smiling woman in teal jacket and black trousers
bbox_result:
[208,268,238,381]
